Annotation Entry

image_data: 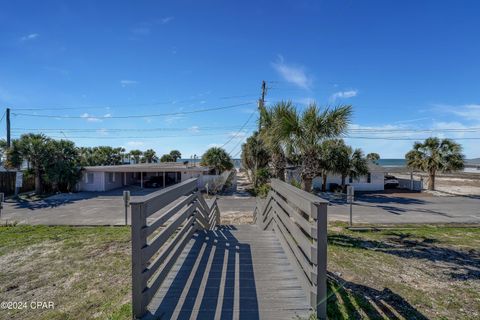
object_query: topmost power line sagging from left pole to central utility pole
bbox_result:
[12,102,253,119]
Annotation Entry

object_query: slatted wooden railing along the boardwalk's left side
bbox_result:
[130,179,220,318]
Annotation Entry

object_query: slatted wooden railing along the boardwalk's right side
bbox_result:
[254,179,328,319]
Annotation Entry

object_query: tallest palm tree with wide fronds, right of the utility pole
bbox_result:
[271,102,352,192]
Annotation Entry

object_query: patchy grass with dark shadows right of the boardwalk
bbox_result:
[328,223,480,319]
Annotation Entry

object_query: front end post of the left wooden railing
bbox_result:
[130,203,147,319]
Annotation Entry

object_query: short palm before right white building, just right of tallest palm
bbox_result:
[333,140,369,189]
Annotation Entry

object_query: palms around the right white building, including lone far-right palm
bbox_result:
[242,101,464,192]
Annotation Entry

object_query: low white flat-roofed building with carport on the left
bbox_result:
[77,162,210,191]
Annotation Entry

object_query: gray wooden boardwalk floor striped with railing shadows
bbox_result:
[144,225,311,320]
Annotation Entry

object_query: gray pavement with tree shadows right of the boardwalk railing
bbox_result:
[328,191,480,223]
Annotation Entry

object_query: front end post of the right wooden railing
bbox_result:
[312,203,328,320]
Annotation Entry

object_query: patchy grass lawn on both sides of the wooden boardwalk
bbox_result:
[0,223,480,319]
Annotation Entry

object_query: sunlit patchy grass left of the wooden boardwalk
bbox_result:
[0,226,131,319]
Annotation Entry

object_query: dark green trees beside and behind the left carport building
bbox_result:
[0,133,185,194]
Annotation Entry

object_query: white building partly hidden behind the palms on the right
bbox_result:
[286,162,386,191]
